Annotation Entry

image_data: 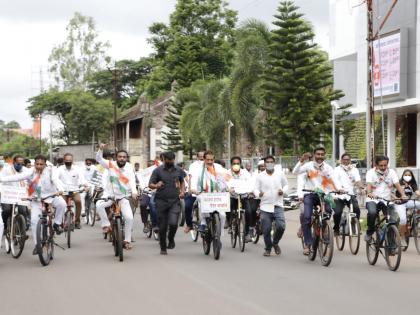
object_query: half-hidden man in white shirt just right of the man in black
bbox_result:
[184,151,204,233]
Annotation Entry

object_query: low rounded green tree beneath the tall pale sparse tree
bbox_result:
[27,90,112,144]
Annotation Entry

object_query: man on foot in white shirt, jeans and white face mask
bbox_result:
[255,156,288,257]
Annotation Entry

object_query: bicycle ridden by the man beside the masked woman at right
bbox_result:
[366,198,401,271]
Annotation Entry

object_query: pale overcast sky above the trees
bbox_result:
[0,0,329,128]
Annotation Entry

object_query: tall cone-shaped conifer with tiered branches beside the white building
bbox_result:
[262,1,341,154]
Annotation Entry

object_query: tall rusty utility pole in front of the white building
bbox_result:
[365,0,398,168]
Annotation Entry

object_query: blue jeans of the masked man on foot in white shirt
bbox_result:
[261,206,286,250]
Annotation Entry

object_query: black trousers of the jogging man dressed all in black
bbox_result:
[155,199,181,250]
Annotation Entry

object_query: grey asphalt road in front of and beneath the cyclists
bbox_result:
[0,211,420,315]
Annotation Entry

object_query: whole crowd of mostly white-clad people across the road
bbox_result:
[0,144,420,262]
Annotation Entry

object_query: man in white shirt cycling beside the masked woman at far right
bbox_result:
[365,156,407,242]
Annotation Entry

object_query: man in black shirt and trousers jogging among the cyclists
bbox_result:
[149,152,186,255]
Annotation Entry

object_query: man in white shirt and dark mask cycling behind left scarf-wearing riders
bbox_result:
[58,153,89,229]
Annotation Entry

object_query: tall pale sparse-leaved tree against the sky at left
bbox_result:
[48,12,110,90]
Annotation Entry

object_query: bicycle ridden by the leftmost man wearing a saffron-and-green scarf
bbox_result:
[34,194,64,266]
